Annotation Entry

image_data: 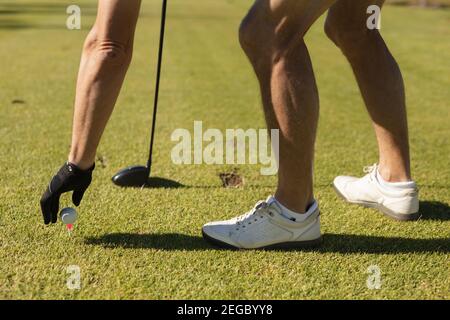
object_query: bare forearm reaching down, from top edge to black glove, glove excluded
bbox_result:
[69,0,141,169]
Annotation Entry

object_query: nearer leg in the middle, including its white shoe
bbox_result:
[202,0,334,249]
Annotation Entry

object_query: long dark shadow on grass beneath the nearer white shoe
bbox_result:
[85,233,450,254]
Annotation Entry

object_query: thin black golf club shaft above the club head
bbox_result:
[147,0,167,174]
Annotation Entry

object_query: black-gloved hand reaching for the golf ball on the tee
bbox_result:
[41,162,95,224]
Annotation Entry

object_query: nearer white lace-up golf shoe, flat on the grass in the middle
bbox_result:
[202,197,322,249]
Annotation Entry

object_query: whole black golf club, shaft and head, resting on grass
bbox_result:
[112,0,167,187]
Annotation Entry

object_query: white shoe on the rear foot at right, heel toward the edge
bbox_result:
[333,164,419,221]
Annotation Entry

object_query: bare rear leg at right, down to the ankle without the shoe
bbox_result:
[325,0,411,182]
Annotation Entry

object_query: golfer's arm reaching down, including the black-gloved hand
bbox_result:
[40,0,141,224]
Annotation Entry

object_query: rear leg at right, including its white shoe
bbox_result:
[325,0,419,221]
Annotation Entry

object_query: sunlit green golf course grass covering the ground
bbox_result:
[0,0,450,299]
